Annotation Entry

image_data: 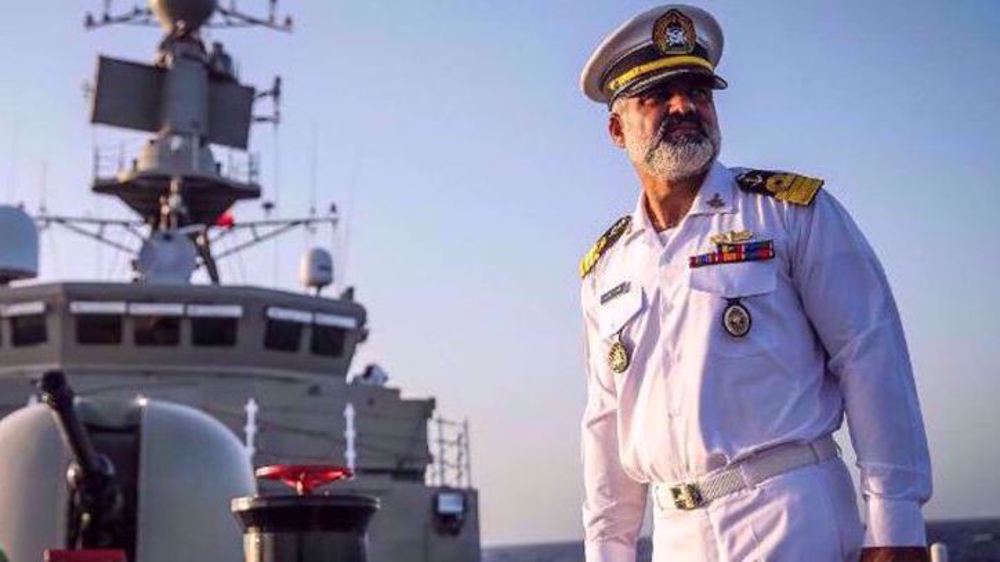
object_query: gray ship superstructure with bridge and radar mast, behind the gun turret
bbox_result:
[0,0,480,562]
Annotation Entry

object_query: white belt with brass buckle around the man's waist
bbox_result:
[653,435,840,510]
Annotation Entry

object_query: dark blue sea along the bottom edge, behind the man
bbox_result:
[483,519,1000,562]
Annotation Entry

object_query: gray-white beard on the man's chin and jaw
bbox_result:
[626,129,721,181]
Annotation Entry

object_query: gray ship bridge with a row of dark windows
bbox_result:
[0,282,367,379]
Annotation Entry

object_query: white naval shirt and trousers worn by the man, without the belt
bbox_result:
[581,163,931,562]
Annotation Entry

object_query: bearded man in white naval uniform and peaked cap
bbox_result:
[580,5,931,562]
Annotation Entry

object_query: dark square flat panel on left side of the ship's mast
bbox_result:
[90,57,163,132]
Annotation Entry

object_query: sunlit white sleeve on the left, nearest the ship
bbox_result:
[580,286,647,562]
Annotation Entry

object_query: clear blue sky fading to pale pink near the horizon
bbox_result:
[0,0,1000,544]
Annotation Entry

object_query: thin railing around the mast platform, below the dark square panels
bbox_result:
[92,141,260,184]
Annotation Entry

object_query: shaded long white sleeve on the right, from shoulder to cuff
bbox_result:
[793,193,931,546]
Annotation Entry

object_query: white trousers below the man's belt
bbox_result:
[653,457,864,562]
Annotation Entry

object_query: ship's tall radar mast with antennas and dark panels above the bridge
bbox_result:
[38,0,337,284]
